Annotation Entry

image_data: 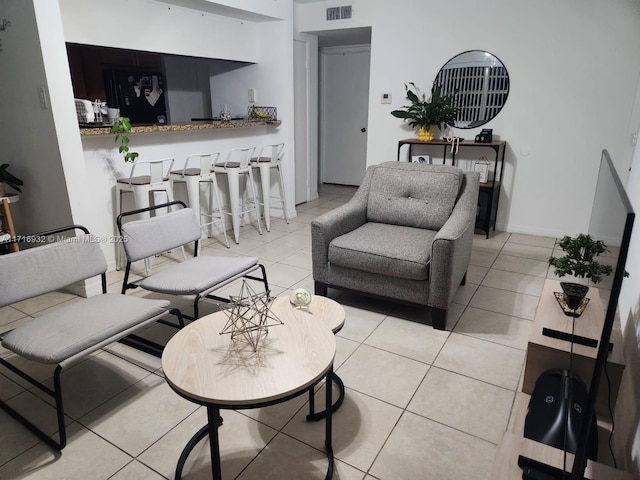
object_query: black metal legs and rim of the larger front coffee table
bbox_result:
[175,366,336,480]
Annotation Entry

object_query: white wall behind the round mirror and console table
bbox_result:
[296,0,640,236]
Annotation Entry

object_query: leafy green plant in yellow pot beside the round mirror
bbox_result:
[391,82,458,142]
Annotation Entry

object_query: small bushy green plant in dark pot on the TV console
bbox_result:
[549,233,613,317]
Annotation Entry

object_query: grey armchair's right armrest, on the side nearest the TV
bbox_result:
[428,172,480,309]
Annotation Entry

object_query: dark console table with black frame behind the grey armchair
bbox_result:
[398,138,507,238]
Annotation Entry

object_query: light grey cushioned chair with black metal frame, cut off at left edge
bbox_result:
[0,225,184,450]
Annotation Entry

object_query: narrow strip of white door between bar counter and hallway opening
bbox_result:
[293,40,309,205]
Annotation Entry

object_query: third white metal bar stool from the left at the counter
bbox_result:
[213,147,262,243]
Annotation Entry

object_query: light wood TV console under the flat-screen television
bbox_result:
[490,279,635,480]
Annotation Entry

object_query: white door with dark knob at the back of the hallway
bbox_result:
[320,45,370,185]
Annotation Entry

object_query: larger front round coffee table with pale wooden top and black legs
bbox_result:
[162,297,344,480]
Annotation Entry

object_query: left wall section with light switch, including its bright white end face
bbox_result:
[0,0,99,294]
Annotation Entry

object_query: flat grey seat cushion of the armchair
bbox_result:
[329,222,436,281]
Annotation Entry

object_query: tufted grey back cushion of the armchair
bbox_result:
[367,163,464,230]
